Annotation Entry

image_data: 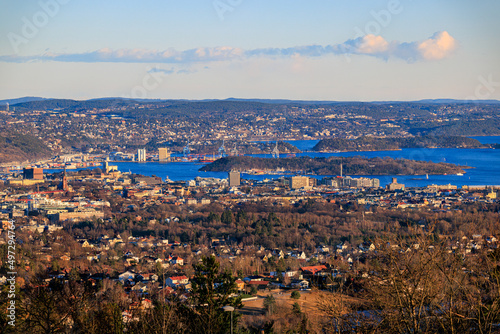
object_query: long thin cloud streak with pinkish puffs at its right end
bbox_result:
[0,31,457,64]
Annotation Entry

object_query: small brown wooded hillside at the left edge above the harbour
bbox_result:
[0,134,52,163]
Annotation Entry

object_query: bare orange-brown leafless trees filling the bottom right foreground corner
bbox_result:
[318,234,500,333]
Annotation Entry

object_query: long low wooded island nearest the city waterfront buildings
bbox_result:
[200,157,465,175]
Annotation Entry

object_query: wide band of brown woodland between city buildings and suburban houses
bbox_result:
[65,197,500,254]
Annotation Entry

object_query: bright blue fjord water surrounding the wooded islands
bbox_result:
[113,136,500,187]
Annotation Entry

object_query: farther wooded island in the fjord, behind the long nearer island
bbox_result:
[313,136,491,152]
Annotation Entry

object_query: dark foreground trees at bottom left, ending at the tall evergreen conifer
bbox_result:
[0,256,242,334]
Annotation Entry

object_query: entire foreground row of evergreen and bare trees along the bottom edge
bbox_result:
[4,231,500,334]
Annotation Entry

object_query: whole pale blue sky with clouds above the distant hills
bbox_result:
[0,0,500,101]
